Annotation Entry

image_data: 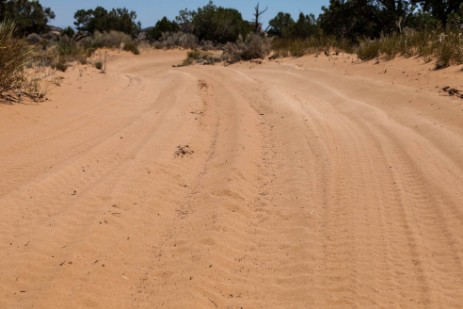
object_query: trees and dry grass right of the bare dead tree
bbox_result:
[268,0,463,69]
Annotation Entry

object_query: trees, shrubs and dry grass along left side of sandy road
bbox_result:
[0,0,140,102]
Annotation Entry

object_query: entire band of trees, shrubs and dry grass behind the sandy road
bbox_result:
[0,0,463,103]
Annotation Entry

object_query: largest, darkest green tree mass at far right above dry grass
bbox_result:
[319,0,463,40]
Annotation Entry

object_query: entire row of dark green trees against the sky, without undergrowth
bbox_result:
[0,0,463,43]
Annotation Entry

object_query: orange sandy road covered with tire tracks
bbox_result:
[0,52,463,308]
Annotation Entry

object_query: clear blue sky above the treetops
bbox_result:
[40,0,329,27]
